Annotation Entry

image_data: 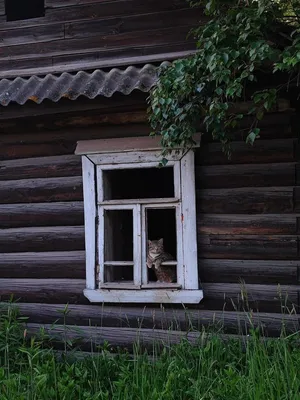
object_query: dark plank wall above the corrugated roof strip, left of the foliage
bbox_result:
[0,0,207,78]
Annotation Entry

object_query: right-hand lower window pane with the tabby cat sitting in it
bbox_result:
[146,208,177,283]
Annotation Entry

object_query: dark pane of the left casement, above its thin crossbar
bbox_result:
[104,210,133,262]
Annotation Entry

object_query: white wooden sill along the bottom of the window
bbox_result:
[84,289,203,304]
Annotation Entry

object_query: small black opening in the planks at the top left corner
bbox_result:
[5,0,45,21]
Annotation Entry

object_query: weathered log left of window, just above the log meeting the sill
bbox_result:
[0,251,85,279]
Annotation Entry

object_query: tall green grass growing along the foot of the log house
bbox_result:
[0,309,300,400]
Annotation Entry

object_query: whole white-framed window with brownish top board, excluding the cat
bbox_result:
[76,137,202,303]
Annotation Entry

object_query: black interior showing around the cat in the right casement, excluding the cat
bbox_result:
[146,208,177,282]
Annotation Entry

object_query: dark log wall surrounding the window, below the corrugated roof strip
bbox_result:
[0,92,300,344]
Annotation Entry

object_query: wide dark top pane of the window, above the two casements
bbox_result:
[103,167,174,200]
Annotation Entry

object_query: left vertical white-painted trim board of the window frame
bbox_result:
[82,156,96,289]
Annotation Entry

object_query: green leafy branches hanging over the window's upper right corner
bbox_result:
[149,0,300,155]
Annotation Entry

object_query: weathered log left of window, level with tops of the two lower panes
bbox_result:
[0,201,84,229]
